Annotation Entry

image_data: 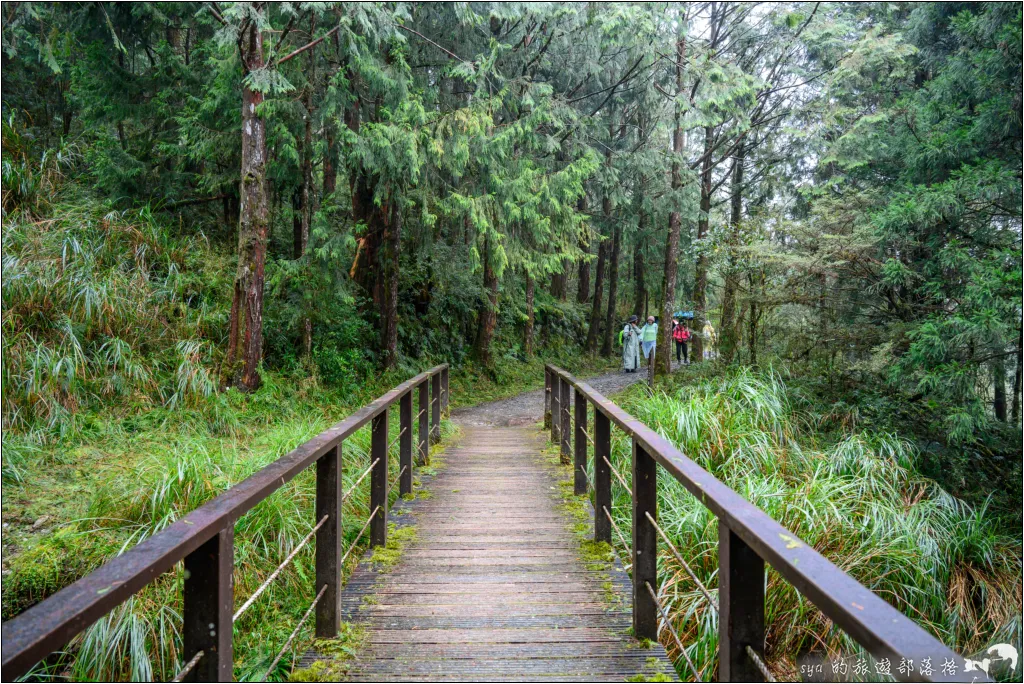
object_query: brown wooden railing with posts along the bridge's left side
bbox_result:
[2,364,449,682]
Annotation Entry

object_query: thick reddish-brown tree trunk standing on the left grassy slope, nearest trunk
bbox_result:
[227,15,268,391]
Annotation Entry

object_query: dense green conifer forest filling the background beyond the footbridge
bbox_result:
[3,2,1021,464]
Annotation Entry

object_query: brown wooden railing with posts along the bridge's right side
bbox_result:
[544,366,989,682]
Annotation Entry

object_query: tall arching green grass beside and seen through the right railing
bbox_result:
[598,370,1022,679]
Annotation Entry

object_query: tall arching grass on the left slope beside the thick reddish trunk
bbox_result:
[2,186,227,448]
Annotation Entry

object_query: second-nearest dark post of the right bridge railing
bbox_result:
[633,439,657,641]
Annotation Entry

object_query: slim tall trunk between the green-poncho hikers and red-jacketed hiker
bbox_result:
[655,25,686,373]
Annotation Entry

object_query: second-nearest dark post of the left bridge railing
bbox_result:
[313,444,342,639]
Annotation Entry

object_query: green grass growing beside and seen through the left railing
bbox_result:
[4,382,453,681]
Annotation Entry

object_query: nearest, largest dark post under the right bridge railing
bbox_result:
[718,520,765,682]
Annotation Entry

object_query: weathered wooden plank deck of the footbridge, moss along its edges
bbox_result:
[300,426,677,682]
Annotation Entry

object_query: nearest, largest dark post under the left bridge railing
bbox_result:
[181,522,234,682]
